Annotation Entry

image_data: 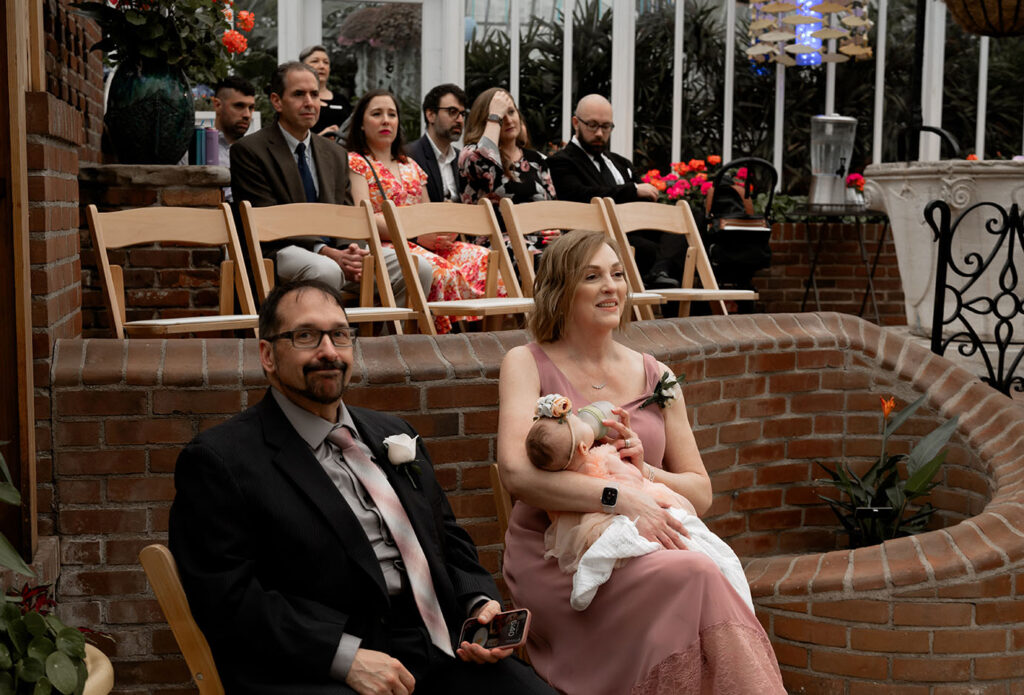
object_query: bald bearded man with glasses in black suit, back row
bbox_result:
[548,94,685,292]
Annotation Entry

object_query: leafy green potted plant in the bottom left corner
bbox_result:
[0,455,113,695]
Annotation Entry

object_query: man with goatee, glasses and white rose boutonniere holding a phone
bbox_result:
[169,280,554,695]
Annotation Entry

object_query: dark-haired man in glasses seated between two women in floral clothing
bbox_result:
[406,84,467,203]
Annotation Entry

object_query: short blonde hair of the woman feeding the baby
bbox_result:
[527,229,631,343]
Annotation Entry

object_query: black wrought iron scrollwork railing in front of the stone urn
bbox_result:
[925,201,1024,395]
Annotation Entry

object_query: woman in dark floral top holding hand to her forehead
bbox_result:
[459,87,559,253]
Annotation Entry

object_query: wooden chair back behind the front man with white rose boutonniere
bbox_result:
[138,544,224,695]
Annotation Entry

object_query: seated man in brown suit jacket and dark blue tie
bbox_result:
[230,61,430,304]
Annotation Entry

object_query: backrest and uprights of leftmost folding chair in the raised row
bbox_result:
[86,203,256,338]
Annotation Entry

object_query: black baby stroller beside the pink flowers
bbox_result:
[702,157,778,311]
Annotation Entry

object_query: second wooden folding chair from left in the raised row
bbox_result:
[241,201,421,334]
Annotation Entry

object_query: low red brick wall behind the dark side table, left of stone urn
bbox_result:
[754,222,906,325]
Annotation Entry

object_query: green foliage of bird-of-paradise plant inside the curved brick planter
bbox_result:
[818,396,957,548]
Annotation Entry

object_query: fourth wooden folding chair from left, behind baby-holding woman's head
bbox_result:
[500,198,665,318]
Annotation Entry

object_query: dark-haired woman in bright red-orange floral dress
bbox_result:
[345,89,506,333]
